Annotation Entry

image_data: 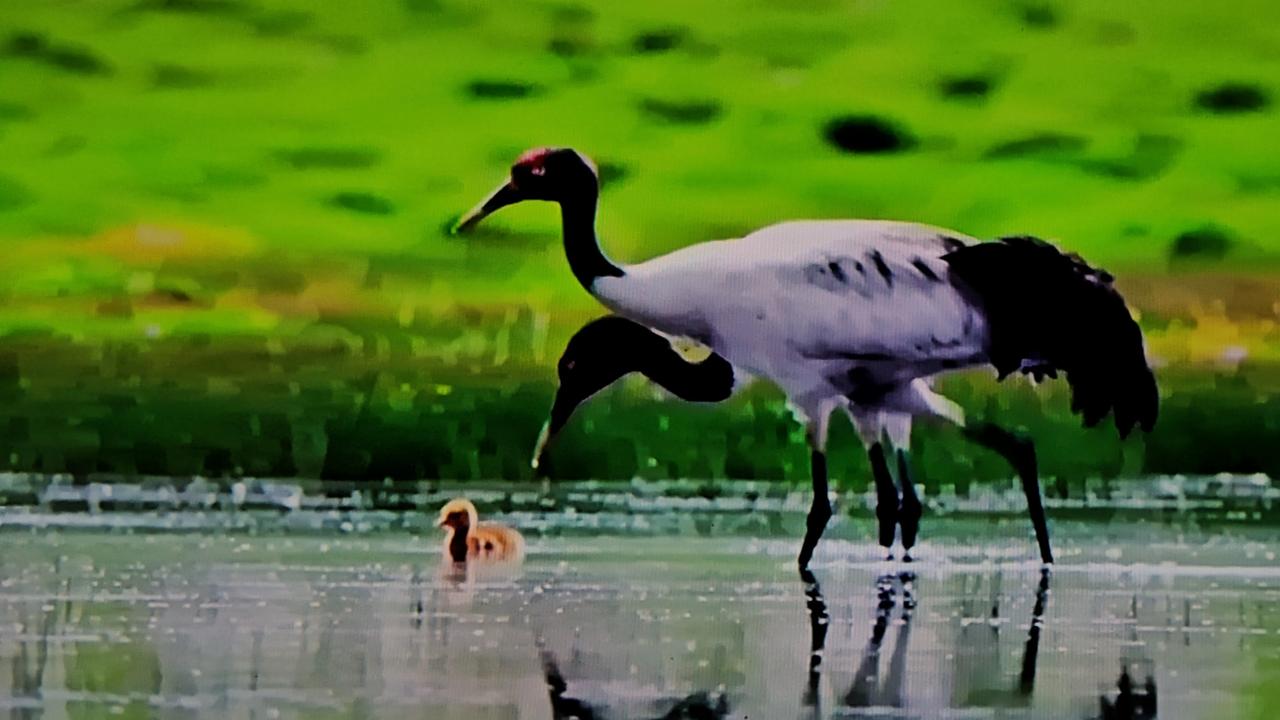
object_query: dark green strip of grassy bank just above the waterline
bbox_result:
[0,324,1280,492]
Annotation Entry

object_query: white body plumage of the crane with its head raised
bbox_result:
[590,220,987,447]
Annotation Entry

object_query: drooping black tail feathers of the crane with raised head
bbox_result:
[945,237,1160,437]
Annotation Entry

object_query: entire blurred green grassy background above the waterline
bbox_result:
[0,0,1280,493]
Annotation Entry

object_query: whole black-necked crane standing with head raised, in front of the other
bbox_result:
[456,149,1158,568]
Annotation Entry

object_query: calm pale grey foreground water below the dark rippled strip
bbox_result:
[0,518,1280,720]
